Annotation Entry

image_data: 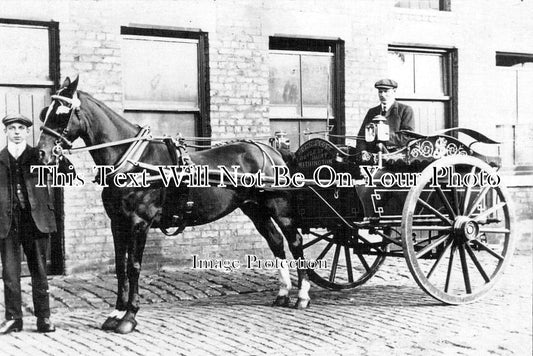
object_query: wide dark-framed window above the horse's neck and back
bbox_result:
[121,27,209,141]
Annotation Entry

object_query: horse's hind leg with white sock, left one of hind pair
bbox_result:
[241,203,292,307]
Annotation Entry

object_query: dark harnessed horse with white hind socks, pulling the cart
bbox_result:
[37,77,310,334]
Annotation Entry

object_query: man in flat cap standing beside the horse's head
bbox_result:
[0,114,56,334]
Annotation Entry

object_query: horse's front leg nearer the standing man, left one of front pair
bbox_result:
[102,220,129,330]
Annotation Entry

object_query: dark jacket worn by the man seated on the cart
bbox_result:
[357,101,415,152]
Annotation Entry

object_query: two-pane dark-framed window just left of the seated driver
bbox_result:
[269,37,344,149]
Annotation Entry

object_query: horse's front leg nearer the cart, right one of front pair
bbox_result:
[115,220,148,334]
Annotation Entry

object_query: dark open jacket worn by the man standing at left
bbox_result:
[0,146,56,239]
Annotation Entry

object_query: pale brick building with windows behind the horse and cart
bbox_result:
[0,0,533,273]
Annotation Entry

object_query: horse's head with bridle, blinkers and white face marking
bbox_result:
[37,77,81,164]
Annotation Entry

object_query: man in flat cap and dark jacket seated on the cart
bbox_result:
[356,79,415,152]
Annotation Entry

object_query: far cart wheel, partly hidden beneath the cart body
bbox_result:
[303,230,389,290]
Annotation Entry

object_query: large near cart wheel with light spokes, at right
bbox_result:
[402,156,514,304]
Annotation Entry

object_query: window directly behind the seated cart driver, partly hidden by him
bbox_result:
[388,46,456,134]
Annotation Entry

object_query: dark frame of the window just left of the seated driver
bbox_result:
[268,34,346,144]
